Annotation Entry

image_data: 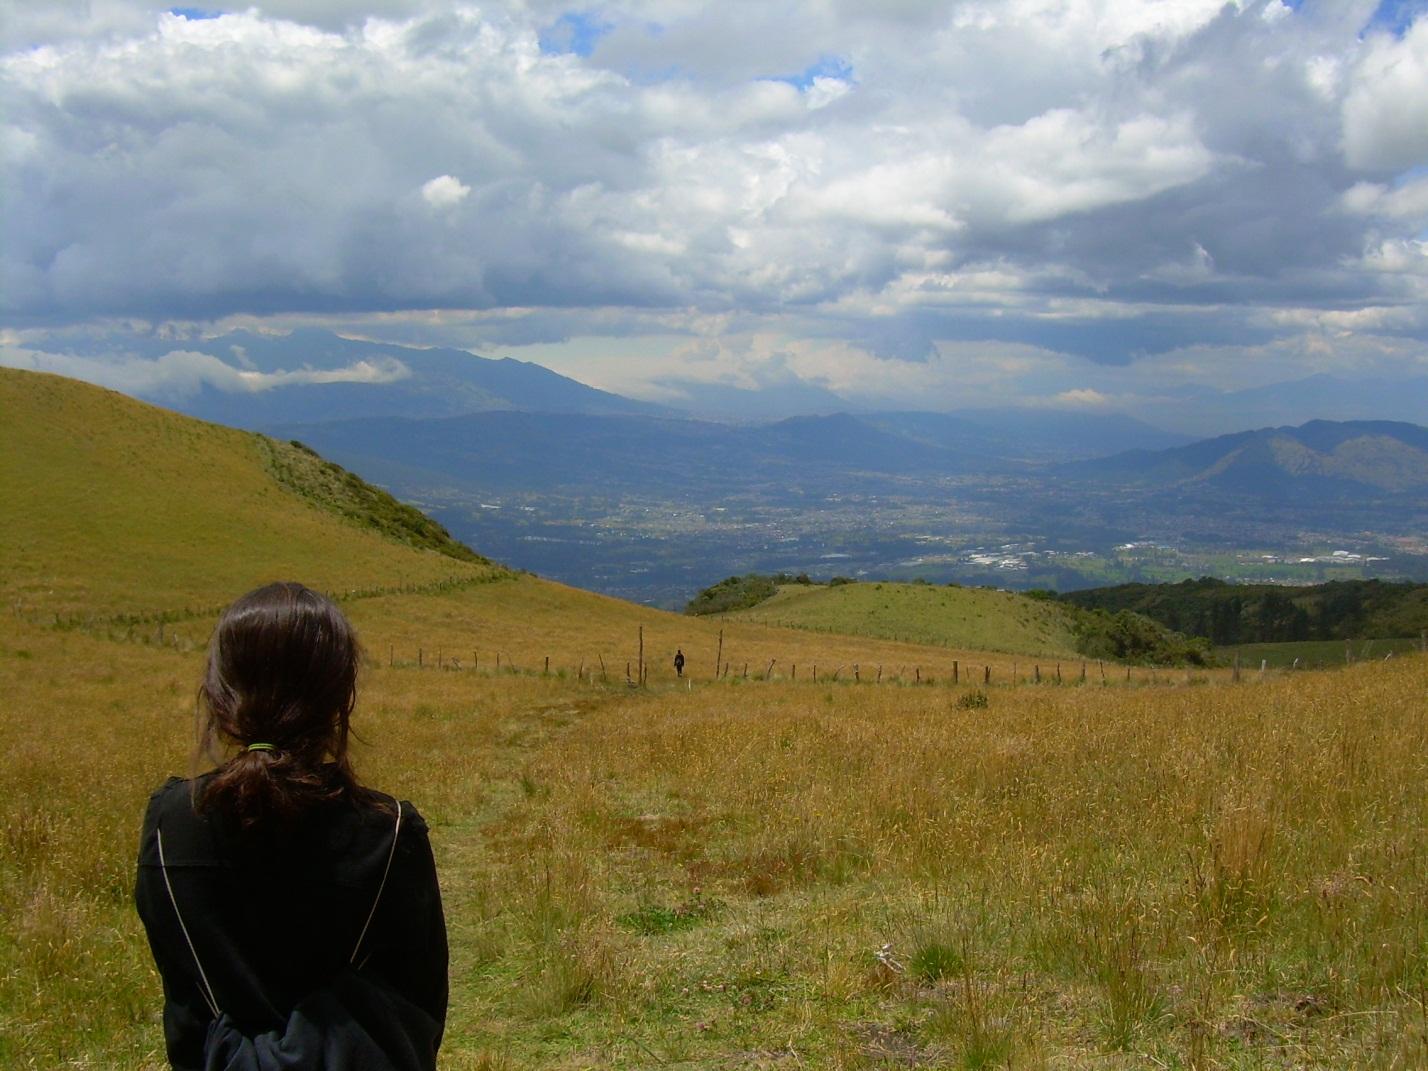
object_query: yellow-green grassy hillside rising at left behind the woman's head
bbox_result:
[0,368,504,618]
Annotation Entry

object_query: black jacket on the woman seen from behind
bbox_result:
[134,778,447,1071]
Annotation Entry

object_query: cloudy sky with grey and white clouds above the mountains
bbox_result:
[0,0,1428,428]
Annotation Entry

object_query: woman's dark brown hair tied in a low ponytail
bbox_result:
[197,581,366,825]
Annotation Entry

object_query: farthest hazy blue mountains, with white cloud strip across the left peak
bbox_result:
[111,328,1191,471]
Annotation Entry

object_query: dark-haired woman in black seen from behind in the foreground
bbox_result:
[134,583,447,1068]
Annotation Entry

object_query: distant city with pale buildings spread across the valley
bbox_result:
[416,481,1428,608]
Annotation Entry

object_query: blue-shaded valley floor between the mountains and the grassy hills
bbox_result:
[393,476,1428,608]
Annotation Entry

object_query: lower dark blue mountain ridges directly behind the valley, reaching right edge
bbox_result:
[281,410,1428,519]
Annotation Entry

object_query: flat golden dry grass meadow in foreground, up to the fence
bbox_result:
[0,608,1428,1068]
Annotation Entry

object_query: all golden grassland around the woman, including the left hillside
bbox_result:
[8,377,1428,1071]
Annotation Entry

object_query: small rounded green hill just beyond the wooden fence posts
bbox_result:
[724,583,1075,658]
